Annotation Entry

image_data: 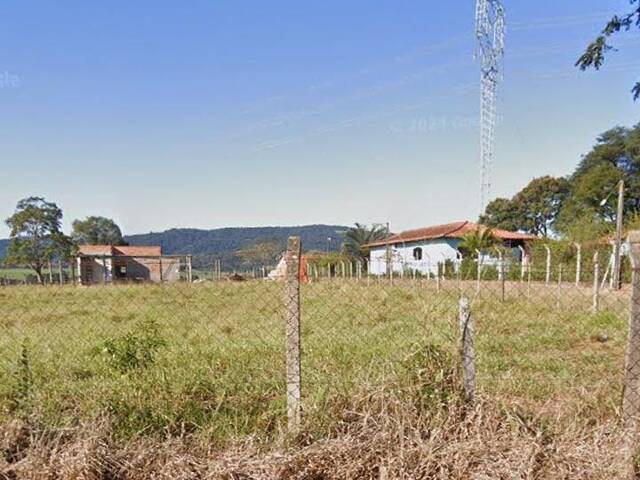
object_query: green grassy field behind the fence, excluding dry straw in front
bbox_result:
[0,279,628,476]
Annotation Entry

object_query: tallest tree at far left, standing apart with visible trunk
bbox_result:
[5,197,71,283]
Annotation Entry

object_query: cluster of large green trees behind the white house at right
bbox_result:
[480,124,640,240]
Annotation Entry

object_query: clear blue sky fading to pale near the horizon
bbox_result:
[0,0,640,236]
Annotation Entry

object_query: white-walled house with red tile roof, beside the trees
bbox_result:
[366,221,537,275]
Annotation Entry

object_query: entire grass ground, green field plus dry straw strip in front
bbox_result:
[0,279,628,478]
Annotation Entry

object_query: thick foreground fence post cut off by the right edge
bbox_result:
[622,230,640,479]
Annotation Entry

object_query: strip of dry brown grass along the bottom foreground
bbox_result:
[0,396,624,480]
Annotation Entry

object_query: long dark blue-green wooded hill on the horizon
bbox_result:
[0,225,348,271]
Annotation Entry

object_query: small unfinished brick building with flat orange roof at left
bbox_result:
[73,245,191,285]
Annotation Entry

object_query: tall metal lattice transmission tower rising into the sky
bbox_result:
[476,0,505,213]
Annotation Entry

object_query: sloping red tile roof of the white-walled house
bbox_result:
[365,221,538,247]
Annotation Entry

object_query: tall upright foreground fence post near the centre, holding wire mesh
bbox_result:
[285,237,302,431]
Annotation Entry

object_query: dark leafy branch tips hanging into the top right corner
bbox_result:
[576,0,640,100]
